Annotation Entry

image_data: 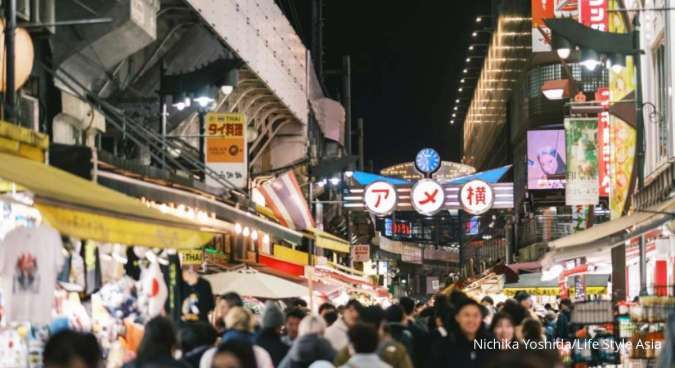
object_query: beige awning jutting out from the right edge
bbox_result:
[541,198,675,269]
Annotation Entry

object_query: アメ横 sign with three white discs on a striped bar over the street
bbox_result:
[344,179,513,216]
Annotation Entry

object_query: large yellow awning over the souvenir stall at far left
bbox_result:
[0,153,212,249]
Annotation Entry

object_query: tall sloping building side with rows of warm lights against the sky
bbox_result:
[464,14,531,169]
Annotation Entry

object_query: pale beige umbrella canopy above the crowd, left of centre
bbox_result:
[204,268,309,299]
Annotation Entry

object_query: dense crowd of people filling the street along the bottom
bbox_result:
[44,291,592,368]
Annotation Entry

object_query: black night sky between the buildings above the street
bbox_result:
[278,0,491,171]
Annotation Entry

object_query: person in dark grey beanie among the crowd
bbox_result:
[255,301,290,367]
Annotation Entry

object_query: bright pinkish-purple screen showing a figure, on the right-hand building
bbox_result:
[527,129,567,190]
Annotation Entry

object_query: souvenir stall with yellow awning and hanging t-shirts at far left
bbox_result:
[0,153,212,367]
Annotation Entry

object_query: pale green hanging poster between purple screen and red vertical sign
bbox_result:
[565,118,599,206]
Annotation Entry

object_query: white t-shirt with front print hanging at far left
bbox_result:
[0,224,63,324]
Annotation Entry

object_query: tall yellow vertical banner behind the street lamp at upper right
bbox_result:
[609,0,637,219]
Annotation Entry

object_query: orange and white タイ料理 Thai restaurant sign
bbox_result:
[204,113,248,188]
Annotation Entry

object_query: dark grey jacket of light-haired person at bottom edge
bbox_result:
[278,334,335,368]
